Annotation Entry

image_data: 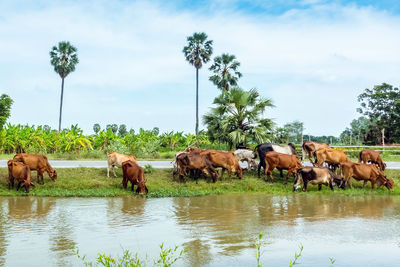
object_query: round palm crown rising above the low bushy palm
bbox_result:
[209,54,242,91]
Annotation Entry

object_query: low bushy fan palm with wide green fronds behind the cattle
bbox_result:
[203,87,274,147]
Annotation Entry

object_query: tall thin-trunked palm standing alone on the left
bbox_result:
[50,42,79,131]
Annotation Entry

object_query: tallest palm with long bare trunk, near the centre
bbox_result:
[182,32,213,135]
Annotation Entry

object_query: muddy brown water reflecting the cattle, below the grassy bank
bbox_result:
[0,194,400,266]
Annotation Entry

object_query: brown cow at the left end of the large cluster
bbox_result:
[176,151,218,183]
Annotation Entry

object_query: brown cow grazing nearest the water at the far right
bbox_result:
[341,162,394,190]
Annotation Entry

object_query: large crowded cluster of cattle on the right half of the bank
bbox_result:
[174,141,394,194]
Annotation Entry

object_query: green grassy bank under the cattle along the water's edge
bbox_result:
[0,168,400,197]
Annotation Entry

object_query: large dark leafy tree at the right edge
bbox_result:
[357,83,400,143]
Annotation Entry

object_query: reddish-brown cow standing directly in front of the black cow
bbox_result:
[265,151,303,184]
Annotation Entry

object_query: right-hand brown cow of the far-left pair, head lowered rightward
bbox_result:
[14,153,57,184]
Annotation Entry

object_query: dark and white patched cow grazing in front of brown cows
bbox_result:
[293,167,346,192]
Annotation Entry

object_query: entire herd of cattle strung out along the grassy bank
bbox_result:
[7,141,394,194]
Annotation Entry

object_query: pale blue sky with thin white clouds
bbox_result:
[0,0,400,136]
